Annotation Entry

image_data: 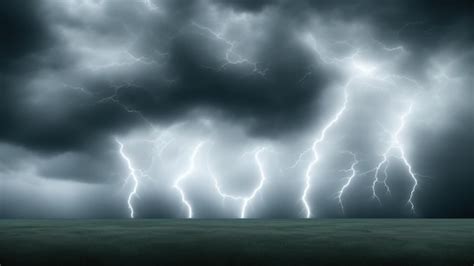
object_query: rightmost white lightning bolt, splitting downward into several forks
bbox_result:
[372,104,418,212]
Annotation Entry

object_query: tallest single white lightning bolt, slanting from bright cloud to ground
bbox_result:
[301,88,351,218]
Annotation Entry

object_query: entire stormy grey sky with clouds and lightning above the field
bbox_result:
[0,0,474,218]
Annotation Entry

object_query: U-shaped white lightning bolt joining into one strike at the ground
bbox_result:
[208,147,267,219]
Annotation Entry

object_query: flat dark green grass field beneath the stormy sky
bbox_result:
[0,219,474,266]
